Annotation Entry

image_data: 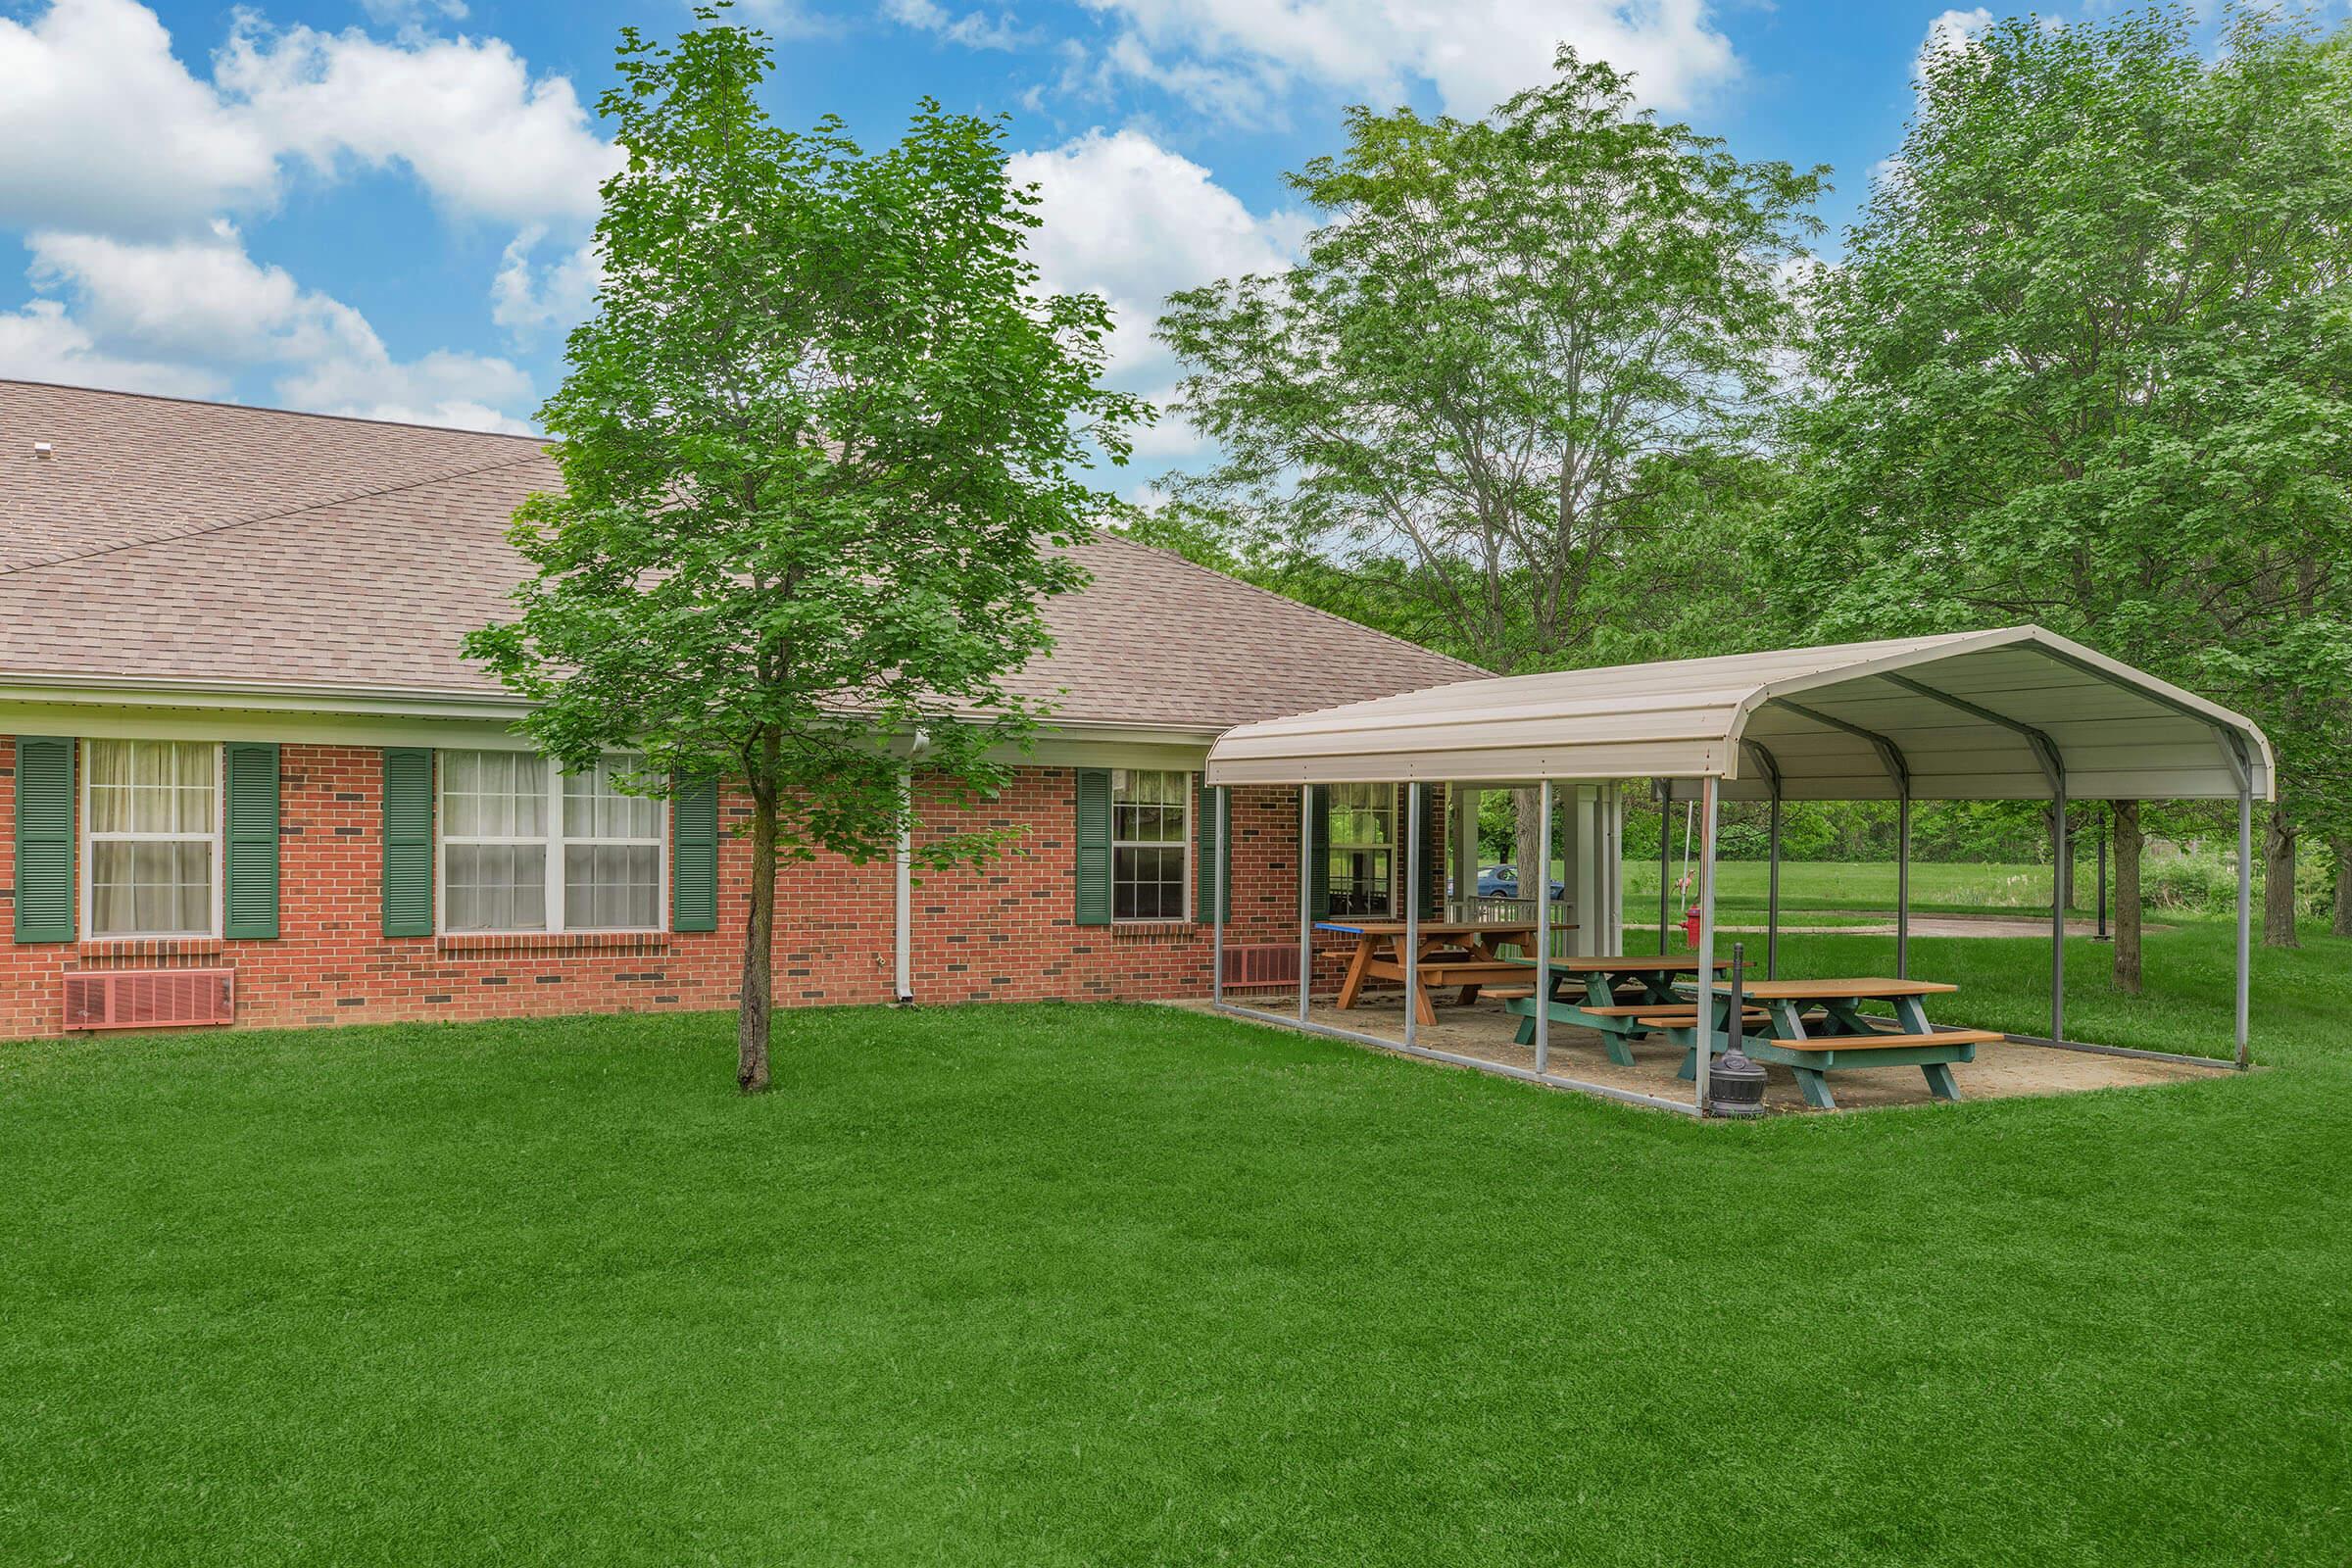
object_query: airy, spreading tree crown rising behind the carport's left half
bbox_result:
[1159,49,1821,672]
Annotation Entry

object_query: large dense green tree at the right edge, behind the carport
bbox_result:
[1789,10,2352,985]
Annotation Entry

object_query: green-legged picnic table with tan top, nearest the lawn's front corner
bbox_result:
[1660,976,2001,1109]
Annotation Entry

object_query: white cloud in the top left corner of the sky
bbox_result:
[0,0,277,232]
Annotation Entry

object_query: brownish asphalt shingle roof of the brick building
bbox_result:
[0,381,1482,729]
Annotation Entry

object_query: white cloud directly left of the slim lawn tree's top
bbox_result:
[214,19,621,223]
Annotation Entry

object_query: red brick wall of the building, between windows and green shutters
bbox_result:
[0,736,1336,1039]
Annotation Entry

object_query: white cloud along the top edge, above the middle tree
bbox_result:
[1087,0,1739,116]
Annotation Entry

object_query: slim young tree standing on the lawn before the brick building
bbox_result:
[468,10,1139,1093]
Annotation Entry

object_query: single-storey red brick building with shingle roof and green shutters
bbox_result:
[0,381,1480,1039]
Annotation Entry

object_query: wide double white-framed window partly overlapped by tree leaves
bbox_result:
[435,753,670,933]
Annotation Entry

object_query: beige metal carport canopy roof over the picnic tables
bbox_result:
[1206,625,2275,800]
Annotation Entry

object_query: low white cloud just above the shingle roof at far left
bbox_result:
[19,223,531,430]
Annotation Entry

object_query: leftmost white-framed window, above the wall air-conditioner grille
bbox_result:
[82,741,221,938]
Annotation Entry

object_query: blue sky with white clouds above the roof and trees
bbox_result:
[0,0,2023,494]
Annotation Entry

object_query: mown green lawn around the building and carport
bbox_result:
[0,926,2352,1568]
